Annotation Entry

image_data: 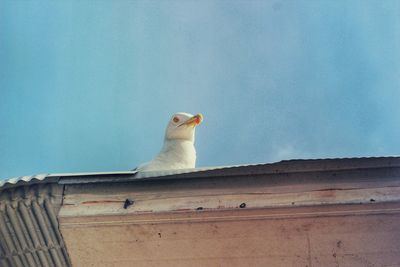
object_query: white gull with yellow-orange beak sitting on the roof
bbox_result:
[136,112,203,171]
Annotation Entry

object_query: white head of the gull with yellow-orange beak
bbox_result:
[165,112,203,142]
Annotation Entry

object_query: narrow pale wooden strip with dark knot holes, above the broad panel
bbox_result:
[60,187,400,217]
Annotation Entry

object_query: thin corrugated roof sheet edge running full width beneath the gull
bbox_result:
[0,156,400,190]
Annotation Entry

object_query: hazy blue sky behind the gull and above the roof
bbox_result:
[0,0,400,178]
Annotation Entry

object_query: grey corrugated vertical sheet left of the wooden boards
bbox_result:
[0,184,71,267]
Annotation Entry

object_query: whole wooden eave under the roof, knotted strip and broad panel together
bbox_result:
[59,163,400,267]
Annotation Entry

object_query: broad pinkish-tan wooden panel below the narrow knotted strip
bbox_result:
[61,204,400,266]
